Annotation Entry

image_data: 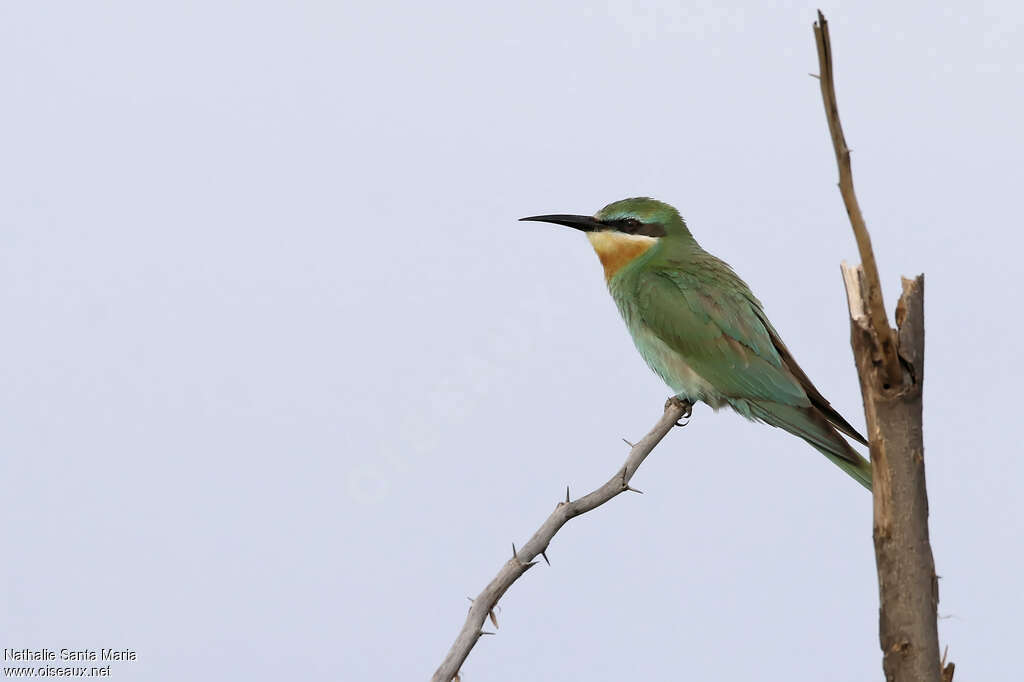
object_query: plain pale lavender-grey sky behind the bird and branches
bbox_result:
[0,0,1024,682]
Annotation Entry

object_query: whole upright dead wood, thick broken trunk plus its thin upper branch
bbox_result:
[814,11,953,682]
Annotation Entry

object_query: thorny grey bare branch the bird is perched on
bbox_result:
[431,400,687,682]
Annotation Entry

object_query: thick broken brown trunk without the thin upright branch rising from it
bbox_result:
[843,264,952,682]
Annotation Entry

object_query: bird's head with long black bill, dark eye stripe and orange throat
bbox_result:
[520,197,693,281]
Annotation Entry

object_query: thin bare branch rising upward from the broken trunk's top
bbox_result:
[814,10,902,389]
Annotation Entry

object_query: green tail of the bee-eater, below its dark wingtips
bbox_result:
[750,401,871,491]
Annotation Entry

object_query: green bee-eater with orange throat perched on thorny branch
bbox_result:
[522,198,871,489]
